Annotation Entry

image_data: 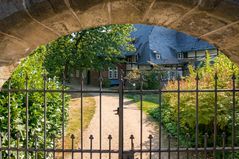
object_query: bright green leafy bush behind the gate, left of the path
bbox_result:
[0,46,69,158]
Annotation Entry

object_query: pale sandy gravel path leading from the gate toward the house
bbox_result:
[69,87,185,159]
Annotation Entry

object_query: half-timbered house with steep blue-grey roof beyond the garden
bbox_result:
[71,24,218,85]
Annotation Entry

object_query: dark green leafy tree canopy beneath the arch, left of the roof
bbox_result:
[45,25,134,78]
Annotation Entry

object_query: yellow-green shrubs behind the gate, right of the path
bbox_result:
[154,54,239,149]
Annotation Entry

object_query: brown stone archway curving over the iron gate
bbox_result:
[0,0,239,85]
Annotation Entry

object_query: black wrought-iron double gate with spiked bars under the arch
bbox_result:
[0,73,239,159]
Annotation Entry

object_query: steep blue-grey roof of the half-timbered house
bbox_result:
[129,24,215,64]
